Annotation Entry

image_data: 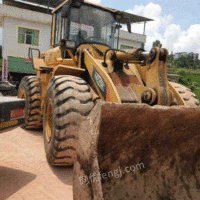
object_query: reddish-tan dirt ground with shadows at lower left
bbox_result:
[0,127,73,200]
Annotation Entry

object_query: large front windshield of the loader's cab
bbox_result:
[68,4,115,47]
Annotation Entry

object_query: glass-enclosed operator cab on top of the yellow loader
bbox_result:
[52,1,116,47]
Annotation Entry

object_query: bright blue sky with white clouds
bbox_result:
[0,0,200,53]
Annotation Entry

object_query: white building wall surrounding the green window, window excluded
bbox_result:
[0,5,52,58]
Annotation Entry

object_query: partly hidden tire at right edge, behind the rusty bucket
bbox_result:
[170,82,200,106]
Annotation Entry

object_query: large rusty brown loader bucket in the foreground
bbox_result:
[73,102,200,200]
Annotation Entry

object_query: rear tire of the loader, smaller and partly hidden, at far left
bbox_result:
[18,76,42,129]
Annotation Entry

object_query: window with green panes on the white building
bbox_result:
[18,27,39,46]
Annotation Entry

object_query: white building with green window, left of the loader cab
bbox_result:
[0,0,52,58]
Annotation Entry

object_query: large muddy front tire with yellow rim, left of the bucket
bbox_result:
[43,76,94,166]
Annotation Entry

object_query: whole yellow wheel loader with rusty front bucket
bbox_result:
[19,0,200,200]
